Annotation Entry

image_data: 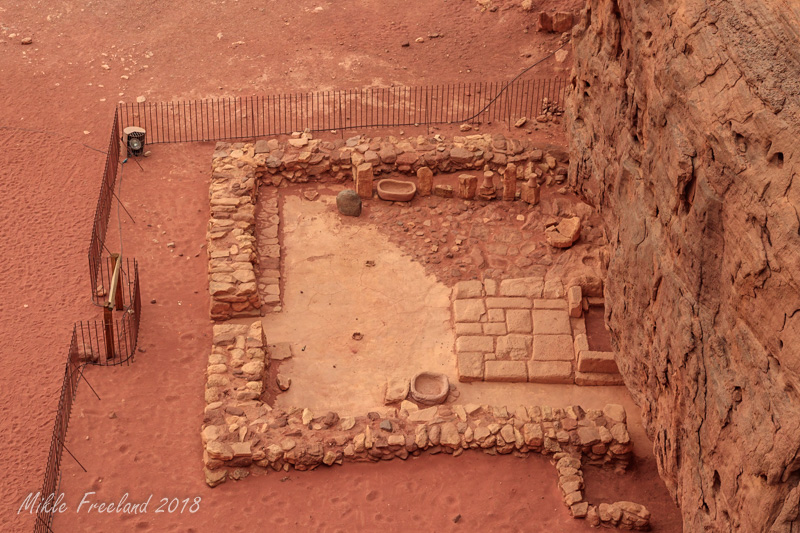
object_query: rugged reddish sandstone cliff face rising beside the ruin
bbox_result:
[567,0,800,531]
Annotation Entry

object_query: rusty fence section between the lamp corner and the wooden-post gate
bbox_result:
[89,110,120,304]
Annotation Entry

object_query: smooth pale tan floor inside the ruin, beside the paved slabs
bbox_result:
[262,191,651,451]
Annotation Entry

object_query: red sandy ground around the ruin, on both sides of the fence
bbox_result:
[0,0,680,531]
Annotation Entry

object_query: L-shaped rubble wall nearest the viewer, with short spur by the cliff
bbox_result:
[202,321,650,531]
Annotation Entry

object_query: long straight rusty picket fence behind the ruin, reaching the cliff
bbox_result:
[118,78,567,144]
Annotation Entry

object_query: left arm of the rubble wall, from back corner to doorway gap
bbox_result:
[206,151,261,320]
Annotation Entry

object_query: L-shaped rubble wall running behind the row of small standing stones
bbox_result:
[206,132,584,320]
